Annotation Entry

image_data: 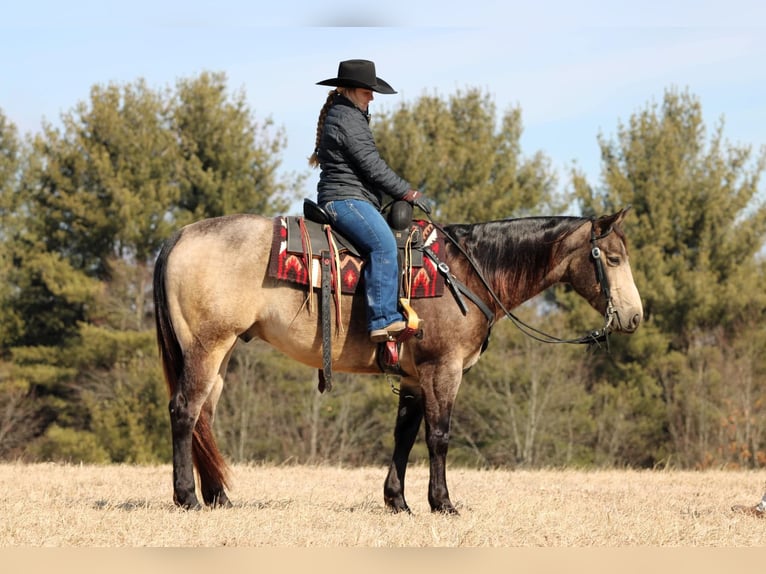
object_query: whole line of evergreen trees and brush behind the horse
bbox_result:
[0,72,766,468]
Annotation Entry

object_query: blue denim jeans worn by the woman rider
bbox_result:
[322,199,404,331]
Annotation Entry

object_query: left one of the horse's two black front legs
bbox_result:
[383,386,423,512]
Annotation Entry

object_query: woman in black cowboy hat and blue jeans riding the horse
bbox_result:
[309,60,430,343]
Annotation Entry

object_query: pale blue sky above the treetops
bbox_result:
[0,0,766,213]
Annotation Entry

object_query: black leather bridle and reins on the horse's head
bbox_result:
[426,214,615,352]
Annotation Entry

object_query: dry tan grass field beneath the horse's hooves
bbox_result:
[0,464,766,548]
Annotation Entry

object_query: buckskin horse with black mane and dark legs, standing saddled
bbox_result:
[153,208,643,514]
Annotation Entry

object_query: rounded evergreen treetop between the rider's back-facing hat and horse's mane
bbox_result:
[373,90,560,222]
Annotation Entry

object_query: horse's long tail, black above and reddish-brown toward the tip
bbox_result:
[153,232,228,492]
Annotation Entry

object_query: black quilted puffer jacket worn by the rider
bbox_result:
[317,94,411,209]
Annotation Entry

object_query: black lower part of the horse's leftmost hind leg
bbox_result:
[168,391,200,508]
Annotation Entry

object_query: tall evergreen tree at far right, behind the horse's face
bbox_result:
[574,89,766,466]
